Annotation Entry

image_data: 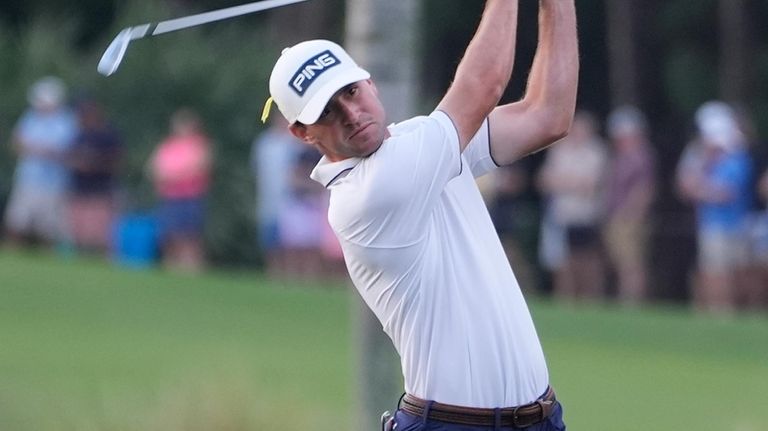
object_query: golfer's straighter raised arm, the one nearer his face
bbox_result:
[437,0,520,151]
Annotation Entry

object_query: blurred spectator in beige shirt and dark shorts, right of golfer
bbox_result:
[538,111,607,299]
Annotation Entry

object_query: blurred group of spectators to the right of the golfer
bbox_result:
[481,101,768,313]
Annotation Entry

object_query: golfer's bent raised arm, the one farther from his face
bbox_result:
[490,0,579,165]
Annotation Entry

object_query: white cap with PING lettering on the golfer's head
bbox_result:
[269,40,371,124]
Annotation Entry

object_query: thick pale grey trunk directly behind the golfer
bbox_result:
[346,0,419,430]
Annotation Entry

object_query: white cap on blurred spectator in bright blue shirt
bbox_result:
[696,101,743,151]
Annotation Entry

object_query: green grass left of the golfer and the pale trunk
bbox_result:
[0,254,352,430]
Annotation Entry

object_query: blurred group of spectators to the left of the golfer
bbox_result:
[2,77,344,277]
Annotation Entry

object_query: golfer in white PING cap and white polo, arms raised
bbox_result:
[269,0,578,431]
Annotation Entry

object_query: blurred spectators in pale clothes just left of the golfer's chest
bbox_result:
[251,115,346,278]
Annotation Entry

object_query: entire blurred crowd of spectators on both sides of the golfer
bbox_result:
[2,77,768,313]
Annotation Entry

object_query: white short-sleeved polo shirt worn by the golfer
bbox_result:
[312,111,549,407]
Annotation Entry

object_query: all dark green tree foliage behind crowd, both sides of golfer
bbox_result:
[0,0,768,270]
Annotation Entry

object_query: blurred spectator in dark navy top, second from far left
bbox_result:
[67,99,122,253]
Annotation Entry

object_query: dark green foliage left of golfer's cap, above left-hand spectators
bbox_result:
[0,0,278,263]
